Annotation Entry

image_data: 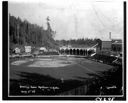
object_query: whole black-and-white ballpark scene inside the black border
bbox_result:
[8,0,124,96]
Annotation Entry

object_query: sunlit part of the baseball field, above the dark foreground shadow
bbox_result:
[10,57,112,80]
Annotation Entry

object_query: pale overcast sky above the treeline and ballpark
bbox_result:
[9,0,123,40]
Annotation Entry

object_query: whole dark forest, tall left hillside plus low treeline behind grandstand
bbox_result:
[9,15,101,49]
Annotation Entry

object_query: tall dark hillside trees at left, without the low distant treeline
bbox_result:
[9,15,56,48]
